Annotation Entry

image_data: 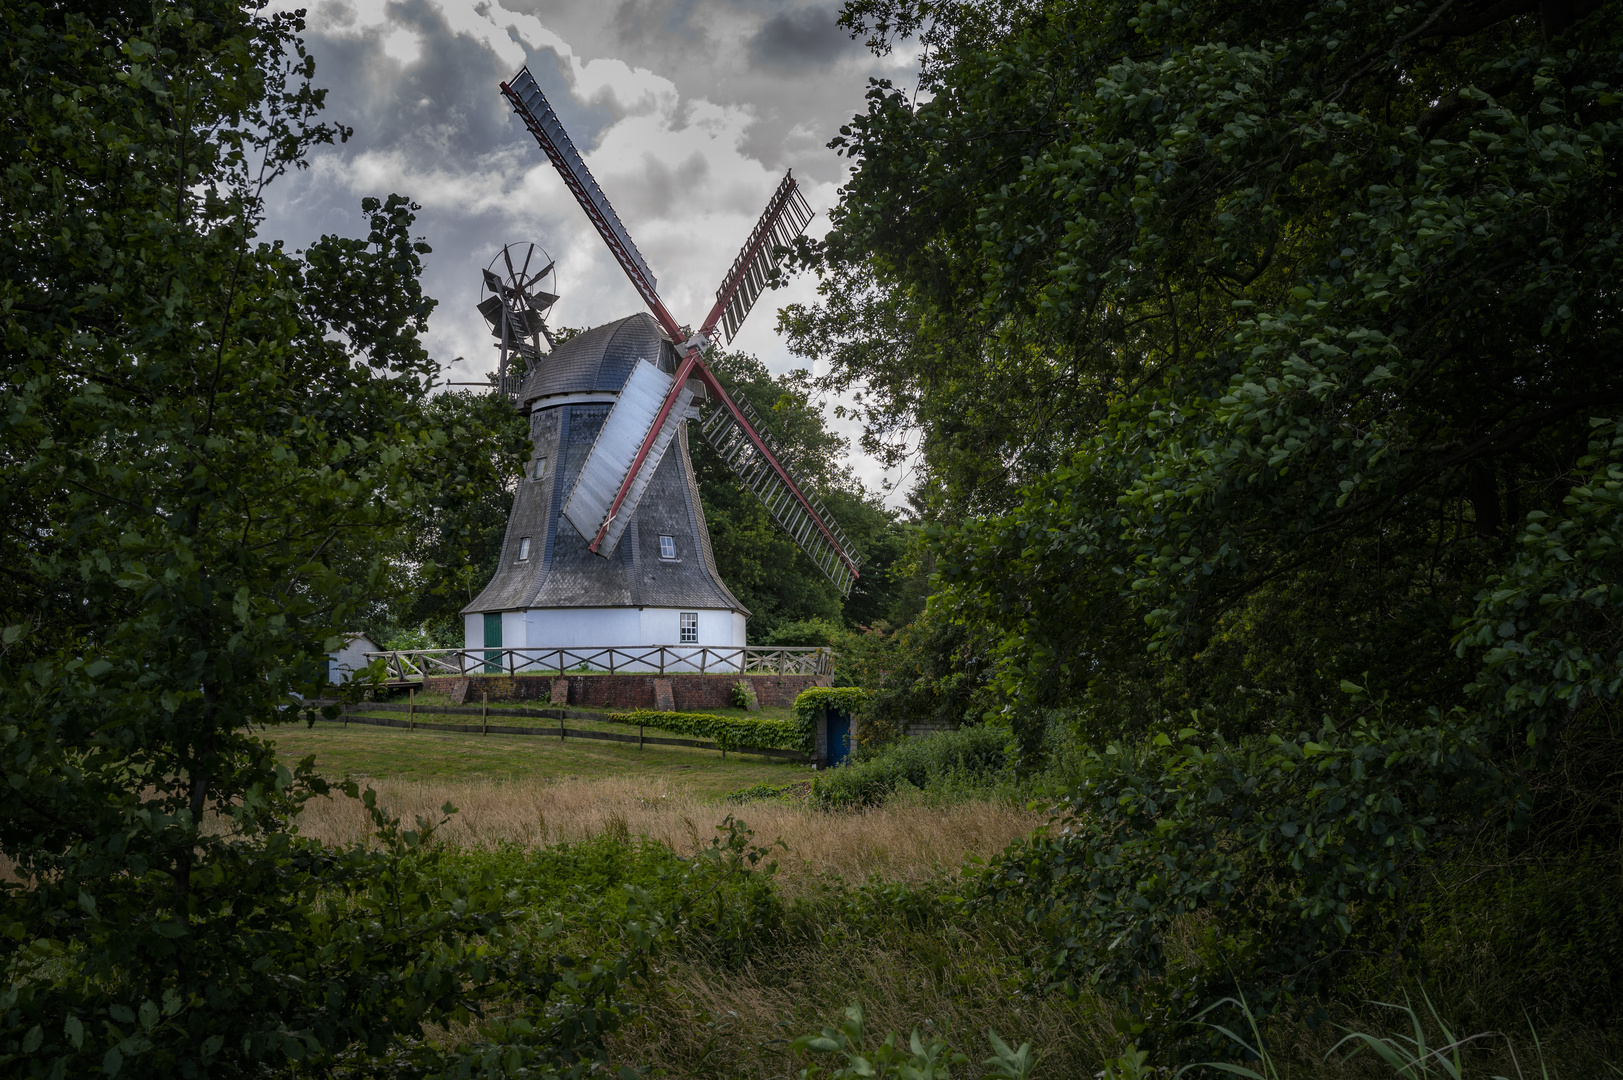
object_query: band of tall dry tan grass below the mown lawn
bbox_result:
[299,778,1042,882]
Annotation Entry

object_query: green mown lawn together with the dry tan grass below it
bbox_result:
[271,714,1040,880]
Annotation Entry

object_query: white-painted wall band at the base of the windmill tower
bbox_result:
[463,607,745,648]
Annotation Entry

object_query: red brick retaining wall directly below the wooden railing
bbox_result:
[422,672,833,713]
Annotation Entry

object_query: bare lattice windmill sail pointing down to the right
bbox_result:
[701,389,862,596]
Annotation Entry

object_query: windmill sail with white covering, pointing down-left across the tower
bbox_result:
[563,361,693,555]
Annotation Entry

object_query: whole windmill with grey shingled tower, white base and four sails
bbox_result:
[463,68,860,650]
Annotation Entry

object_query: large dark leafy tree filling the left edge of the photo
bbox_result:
[0,0,623,1077]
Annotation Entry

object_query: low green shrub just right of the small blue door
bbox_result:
[812,728,1014,807]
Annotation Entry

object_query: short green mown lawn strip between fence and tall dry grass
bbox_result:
[269,721,810,797]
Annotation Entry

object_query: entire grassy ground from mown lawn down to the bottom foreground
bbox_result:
[256,714,1618,1080]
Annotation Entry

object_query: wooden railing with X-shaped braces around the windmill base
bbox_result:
[365,645,834,682]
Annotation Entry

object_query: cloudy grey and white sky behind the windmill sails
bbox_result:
[263,0,914,487]
